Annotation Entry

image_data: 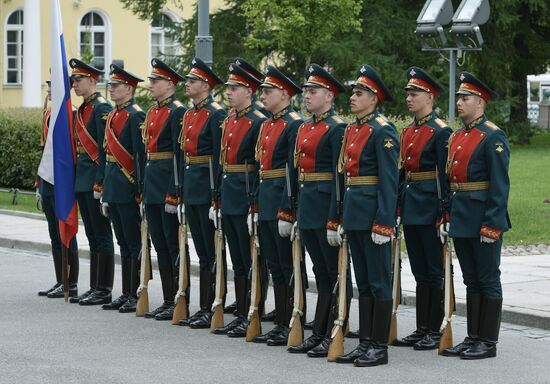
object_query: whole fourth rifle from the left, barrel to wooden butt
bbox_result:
[245,161,262,341]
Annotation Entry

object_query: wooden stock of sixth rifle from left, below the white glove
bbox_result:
[327,235,348,361]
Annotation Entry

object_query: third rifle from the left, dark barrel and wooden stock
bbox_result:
[208,159,226,331]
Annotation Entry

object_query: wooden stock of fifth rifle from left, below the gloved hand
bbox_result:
[287,234,305,347]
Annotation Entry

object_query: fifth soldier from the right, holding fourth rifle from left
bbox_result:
[249,65,303,345]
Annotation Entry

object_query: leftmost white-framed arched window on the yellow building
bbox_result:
[4,9,23,84]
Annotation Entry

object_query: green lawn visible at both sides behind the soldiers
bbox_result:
[0,133,550,245]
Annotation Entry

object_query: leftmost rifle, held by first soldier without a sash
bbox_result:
[136,153,152,317]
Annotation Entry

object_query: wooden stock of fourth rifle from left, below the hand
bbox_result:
[246,230,262,342]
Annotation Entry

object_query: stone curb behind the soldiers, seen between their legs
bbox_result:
[0,236,550,330]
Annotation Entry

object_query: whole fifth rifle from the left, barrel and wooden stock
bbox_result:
[286,164,305,347]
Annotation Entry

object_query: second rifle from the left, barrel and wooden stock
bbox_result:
[172,156,189,325]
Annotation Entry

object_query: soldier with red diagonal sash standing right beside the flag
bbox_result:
[69,59,115,305]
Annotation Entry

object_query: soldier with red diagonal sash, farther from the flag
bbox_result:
[102,64,145,313]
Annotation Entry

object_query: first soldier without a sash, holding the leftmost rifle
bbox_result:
[142,58,186,320]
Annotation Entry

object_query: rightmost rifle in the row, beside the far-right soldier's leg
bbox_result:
[435,168,455,354]
